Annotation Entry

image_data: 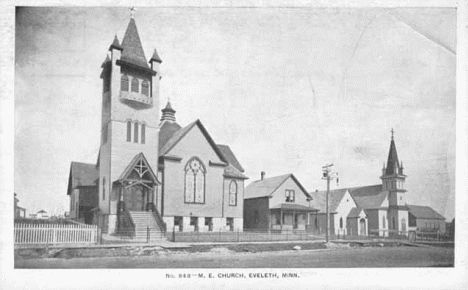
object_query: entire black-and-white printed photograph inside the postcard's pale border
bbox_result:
[4,1,466,289]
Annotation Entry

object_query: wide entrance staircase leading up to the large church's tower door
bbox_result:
[129,211,167,242]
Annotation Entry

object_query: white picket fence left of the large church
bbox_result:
[15,223,98,245]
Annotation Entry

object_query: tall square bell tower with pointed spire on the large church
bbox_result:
[98,13,162,232]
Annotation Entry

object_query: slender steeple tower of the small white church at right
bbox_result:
[380,128,408,235]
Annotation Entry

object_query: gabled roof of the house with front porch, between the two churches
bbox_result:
[244,173,310,199]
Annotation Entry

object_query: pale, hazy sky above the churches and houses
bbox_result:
[14,7,456,220]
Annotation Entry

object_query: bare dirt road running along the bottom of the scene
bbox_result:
[15,247,454,269]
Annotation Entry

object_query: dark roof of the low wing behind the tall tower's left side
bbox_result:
[67,162,99,195]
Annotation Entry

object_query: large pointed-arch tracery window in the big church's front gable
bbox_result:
[184,157,206,203]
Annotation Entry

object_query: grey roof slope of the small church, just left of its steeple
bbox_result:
[349,184,388,209]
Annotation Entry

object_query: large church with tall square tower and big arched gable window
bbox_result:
[67,15,247,234]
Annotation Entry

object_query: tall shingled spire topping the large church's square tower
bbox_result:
[121,18,149,68]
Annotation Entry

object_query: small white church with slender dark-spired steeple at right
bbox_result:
[310,130,409,236]
